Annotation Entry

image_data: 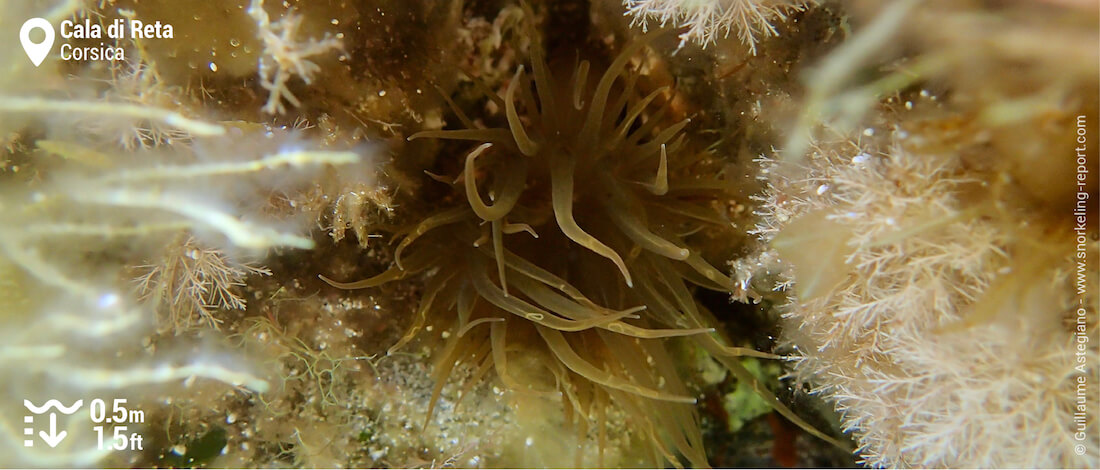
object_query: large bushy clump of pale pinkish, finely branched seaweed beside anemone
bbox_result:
[743,122,1100,467]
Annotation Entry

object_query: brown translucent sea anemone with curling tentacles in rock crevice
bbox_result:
[322,25,836,466]
